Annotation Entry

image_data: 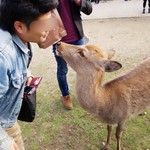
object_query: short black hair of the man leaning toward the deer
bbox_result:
[0,0,58,34]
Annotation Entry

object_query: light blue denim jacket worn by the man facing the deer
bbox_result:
[0,29,29,150]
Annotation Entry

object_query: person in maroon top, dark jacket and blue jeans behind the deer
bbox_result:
[53,0,92,110]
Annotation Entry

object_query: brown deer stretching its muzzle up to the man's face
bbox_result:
[57,42,150,150]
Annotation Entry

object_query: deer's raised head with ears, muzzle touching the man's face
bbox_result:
[57,42,122,75]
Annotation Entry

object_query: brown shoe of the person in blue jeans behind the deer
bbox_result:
[61,95,73,110]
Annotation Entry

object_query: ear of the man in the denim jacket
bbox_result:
[14,21,27,34]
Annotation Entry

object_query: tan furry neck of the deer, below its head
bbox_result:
[76,75,104,114]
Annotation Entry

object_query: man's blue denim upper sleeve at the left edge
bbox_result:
[0,53,9,98]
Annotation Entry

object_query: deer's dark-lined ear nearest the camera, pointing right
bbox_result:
[100,60,122,72]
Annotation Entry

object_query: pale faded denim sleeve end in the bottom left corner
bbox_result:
[0,126,13,150]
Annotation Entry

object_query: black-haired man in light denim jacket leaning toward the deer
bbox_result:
[0,0,58,150]
